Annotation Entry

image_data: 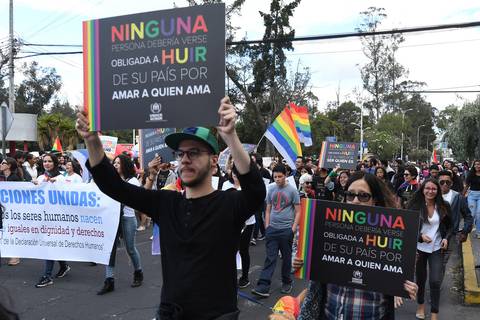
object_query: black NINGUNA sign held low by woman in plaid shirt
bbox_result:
[296,199,419,297]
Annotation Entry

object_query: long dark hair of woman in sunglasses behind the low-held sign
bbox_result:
[346,171,396,208]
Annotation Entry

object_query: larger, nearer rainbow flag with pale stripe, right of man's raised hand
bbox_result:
[265,108,302,168]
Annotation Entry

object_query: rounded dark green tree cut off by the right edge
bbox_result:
[444,96,480,160]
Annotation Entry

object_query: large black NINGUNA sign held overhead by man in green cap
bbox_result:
[83,4,225,131]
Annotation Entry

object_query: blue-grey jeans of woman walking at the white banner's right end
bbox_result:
[105,217,142,278]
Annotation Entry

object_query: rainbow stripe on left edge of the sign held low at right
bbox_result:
[295,198,317,279]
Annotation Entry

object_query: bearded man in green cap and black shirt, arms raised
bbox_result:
[76,97,265,320]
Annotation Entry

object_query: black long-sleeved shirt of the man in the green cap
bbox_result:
[87,157,265,320]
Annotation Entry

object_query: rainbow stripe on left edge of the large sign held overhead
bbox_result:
[83,20,100,131]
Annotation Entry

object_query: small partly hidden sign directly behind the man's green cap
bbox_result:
[139,128,175,168]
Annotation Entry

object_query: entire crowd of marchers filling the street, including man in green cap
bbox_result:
[0,99,480,319]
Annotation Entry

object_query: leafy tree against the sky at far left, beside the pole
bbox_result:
[15,61,62,115]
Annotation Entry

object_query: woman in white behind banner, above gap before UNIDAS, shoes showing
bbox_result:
[32,153,70,288]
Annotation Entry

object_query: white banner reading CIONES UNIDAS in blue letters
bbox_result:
[0,182,120,264]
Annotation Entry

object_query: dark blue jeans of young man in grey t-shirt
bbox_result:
[257,227,293,290]
